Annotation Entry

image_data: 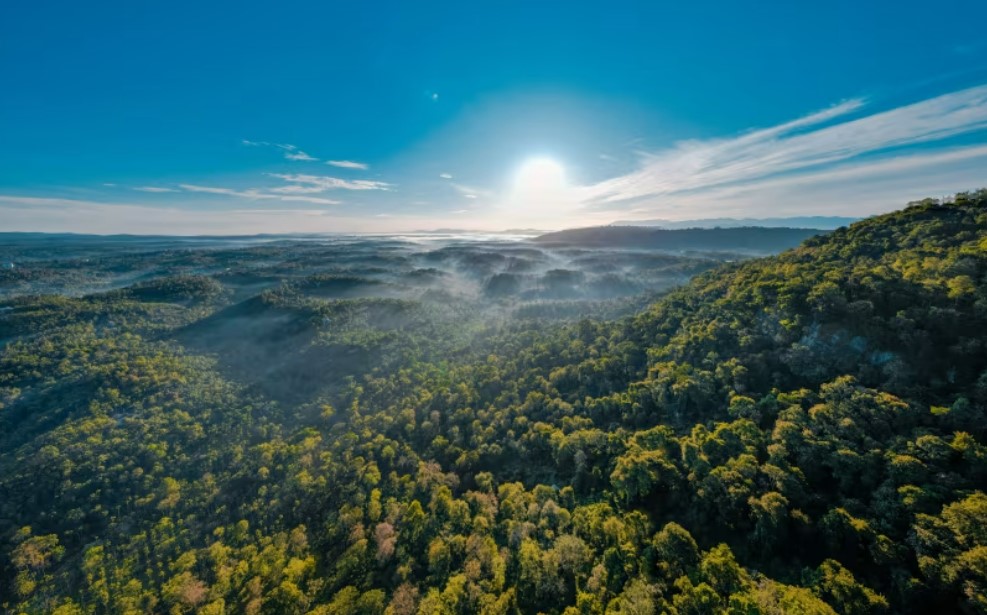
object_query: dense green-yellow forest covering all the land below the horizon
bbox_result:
[0,190,987,615]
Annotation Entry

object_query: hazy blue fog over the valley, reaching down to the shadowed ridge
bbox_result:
[0,234,816,402]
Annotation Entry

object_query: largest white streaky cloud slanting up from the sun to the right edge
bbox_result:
[580,86,987,207]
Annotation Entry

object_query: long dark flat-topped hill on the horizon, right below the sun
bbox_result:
[532,226,826,254]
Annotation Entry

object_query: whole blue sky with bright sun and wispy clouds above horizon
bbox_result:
[0,0,987,235]
